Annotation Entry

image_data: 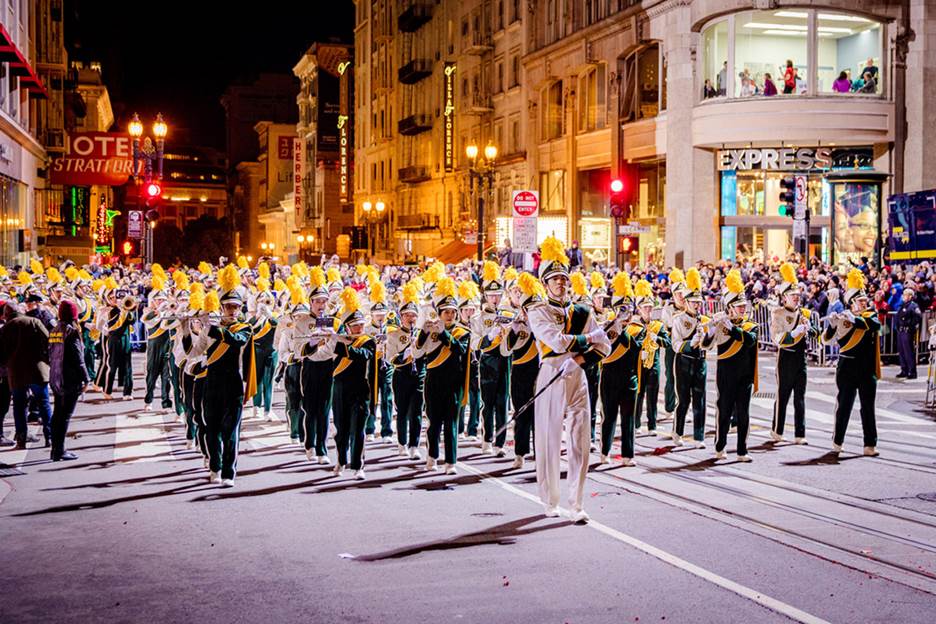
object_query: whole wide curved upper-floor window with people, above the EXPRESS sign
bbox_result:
[700,10,885,99]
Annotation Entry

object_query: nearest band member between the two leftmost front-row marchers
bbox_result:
[293,266,340,465]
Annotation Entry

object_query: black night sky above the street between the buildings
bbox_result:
[65,0,354,149]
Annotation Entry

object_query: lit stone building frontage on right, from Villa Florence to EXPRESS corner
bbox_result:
[355,0,936,265]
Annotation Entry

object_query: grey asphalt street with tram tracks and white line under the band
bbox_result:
[0,354,936,623]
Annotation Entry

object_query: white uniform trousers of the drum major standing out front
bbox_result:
[535,357,591,511]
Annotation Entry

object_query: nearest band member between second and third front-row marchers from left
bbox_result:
[386,280,426,461]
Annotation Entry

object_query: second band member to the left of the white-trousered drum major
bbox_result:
[470,260,510,457]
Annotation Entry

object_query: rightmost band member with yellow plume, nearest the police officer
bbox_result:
[822,269,881,457]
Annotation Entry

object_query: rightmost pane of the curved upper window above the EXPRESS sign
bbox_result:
[816,13,883,95]
